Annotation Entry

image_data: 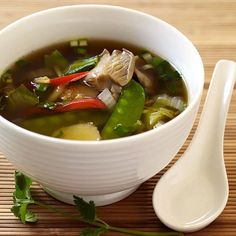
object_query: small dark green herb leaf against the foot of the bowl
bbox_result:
[74,196,97,222]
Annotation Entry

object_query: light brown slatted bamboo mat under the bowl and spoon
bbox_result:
[0,0,236,236]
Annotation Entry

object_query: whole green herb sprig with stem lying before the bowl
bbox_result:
[11,171,183,236]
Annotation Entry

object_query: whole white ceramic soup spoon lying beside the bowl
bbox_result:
[153,60,236,232]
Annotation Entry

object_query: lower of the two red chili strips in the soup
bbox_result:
[54,98,106,112]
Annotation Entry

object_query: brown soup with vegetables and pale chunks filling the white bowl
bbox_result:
[0,39,187,140]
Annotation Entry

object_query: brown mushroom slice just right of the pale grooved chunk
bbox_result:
[134,57,157,94]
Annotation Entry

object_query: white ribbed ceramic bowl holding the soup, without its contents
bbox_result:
[0,5,204,205]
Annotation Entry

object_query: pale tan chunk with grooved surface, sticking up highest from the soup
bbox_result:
[105,49,135,86]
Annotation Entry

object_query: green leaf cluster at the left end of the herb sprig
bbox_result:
[11,171,37,224]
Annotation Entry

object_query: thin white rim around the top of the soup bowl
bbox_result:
[0,4,205,146]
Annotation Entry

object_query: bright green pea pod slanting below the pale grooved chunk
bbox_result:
[101,80,145,139]
